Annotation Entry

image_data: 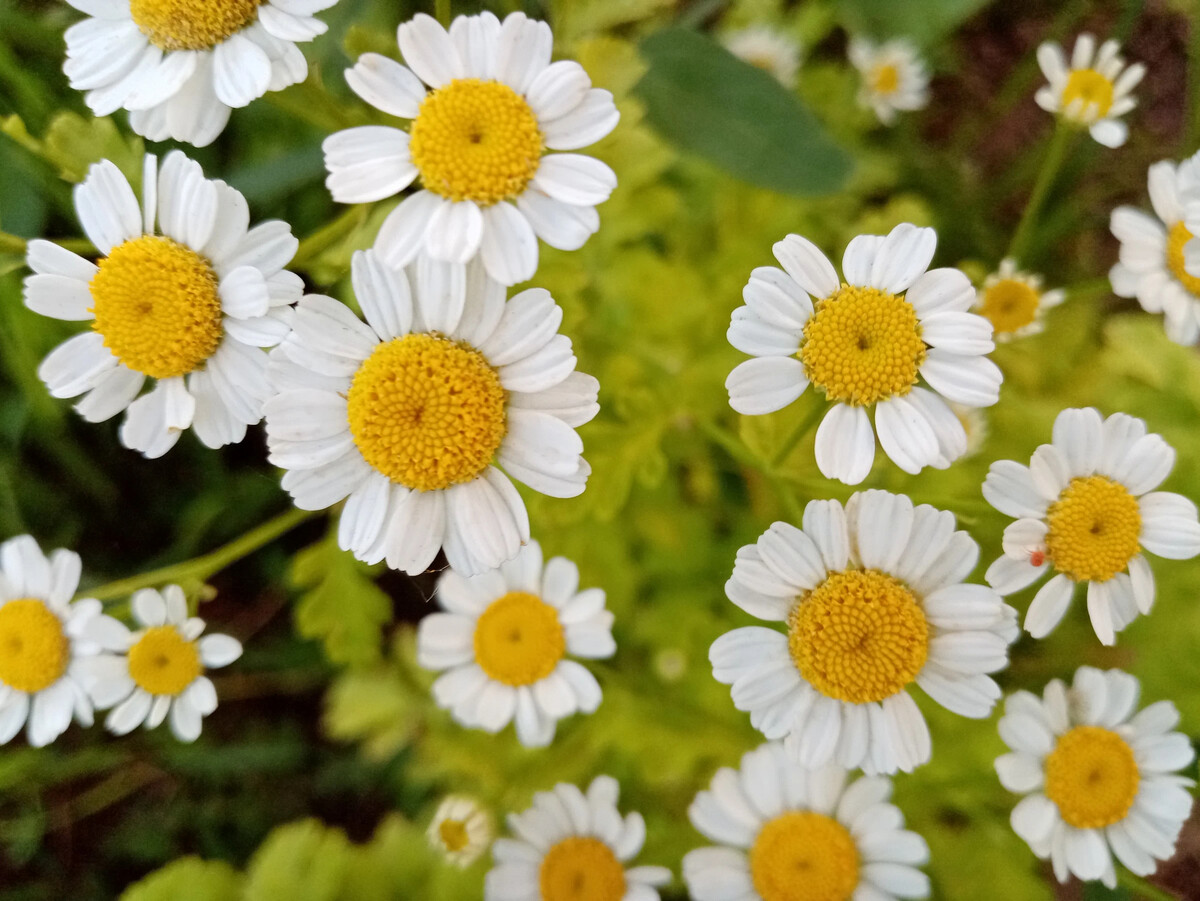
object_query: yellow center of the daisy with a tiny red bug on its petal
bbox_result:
[1046,475,1141,582]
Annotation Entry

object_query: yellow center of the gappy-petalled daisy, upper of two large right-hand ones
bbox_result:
[798,284,925,407]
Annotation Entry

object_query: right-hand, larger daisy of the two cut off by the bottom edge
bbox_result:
[683,741,929,901]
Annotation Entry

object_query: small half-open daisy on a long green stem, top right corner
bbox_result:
[1034,34,1146,148]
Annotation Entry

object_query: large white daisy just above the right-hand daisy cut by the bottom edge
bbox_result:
[709,491,1018,773]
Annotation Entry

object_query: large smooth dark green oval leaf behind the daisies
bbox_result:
[634,28,851,194]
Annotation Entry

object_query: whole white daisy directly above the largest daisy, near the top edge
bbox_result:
[324,12,619,284]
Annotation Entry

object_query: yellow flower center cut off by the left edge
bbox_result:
[0,597,71,695]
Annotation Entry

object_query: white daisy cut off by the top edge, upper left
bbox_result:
[62,0,337,148]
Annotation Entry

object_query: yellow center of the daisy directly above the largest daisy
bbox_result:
[408,78,544,206]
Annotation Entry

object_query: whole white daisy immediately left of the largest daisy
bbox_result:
[25,150,304,457]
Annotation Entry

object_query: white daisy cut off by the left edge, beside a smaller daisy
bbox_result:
[0,535,101,747]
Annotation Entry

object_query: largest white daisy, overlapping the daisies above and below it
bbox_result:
[264,251,600,575]
